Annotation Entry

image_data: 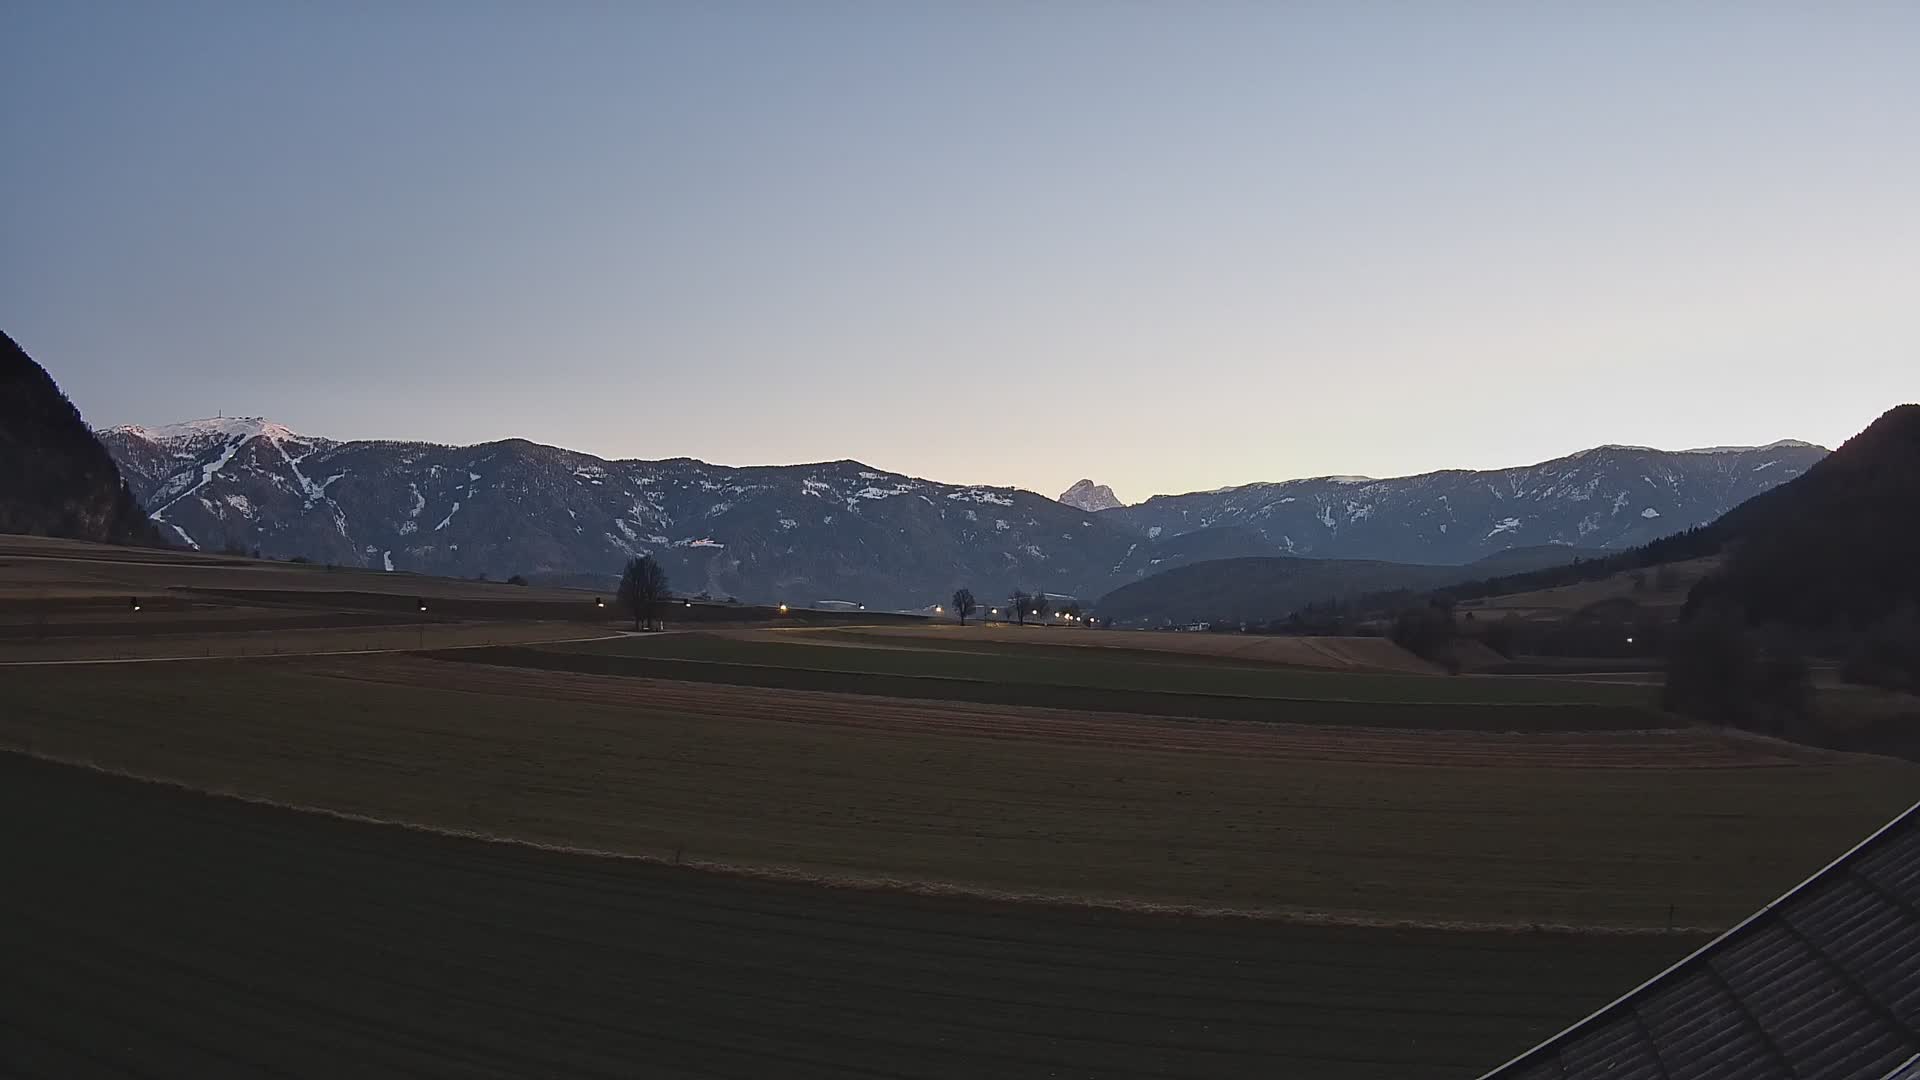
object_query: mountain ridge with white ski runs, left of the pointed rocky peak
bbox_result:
[102,419,1139,609]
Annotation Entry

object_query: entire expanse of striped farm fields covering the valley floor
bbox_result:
[0,542,1920,1078]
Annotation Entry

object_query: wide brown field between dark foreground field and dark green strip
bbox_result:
[0,645,1920,928]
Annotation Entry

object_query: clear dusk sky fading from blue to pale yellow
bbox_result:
[0,0,1920,502]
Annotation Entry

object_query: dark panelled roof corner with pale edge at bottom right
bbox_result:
[1484,805,1920,1080]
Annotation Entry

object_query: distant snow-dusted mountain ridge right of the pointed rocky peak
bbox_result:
[1100,442,1826,563]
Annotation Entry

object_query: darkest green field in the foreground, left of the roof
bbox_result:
[0,753,1697,1078]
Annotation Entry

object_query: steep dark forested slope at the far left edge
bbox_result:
[0,332,159,544]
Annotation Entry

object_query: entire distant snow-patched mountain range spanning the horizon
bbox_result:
[100,417,1826,609]
